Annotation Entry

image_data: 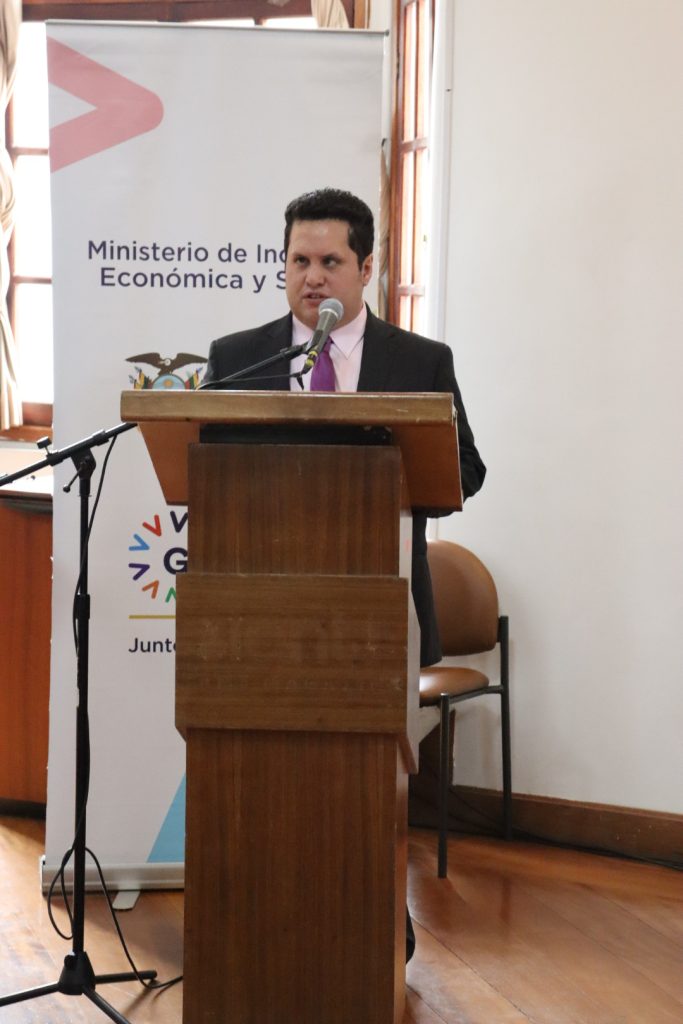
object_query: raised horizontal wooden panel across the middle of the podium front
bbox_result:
[176,572,411,735]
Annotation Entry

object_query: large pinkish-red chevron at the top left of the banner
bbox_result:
[47,38,164,171]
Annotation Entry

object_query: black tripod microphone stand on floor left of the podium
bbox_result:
[0,423,157,1024]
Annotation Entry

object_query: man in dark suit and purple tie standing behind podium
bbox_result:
[204,188,486,665]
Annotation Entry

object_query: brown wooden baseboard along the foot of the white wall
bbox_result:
[411,785,683,866]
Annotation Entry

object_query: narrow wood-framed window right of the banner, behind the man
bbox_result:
[389,0,433,332]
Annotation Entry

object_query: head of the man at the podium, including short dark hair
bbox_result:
[285,188,375,330]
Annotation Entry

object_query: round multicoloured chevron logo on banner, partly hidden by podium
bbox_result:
[128,509,187,604]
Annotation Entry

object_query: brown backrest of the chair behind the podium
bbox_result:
[427,541,499,655]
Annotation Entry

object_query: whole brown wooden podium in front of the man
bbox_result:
[122,390,462,1024]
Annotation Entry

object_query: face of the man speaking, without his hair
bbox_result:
[285,220,373,330]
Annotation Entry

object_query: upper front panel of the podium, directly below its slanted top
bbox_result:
[187,444,410,577]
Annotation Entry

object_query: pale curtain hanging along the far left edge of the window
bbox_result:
[0,0,22,430]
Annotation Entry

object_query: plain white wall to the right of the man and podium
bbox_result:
[439,0,683,813]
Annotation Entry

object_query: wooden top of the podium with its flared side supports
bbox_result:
[121,389,462,511]
